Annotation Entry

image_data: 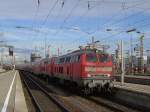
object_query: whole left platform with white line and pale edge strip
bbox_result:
[0,70,28,112]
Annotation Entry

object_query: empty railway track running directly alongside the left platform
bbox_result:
[22,72,70,112]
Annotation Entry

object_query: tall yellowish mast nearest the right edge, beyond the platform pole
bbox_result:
[140,35,144,73]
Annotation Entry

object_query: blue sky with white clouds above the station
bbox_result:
[0,0,150,59]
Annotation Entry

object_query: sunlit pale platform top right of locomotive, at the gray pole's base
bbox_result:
[113,81,150,95]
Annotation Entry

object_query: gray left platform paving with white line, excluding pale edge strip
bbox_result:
[0,71,15,112]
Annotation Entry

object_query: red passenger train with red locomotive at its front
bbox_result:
[26,49,113,93]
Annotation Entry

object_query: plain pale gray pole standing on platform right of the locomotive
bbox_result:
[120,40,125,85]
